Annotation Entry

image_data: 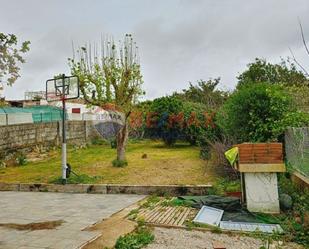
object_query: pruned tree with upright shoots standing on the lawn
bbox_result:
[69,34,143,161]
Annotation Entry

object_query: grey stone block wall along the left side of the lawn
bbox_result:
[0,121,98,157]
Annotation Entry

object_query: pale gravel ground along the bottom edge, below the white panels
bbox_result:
[146,228,303,249]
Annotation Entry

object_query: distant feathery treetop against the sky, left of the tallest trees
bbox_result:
[174,78,228,110]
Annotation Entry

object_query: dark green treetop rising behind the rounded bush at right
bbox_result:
[237,58,308,88]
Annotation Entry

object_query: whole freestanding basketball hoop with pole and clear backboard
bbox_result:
[46,74,79,184]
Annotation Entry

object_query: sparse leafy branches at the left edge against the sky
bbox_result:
[0,33,30,86]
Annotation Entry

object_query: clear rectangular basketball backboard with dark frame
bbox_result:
[46,76,79,101]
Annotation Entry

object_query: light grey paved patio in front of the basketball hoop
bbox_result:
[0,191,145,249]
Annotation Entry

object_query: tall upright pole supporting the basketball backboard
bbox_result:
[61,74,67,184]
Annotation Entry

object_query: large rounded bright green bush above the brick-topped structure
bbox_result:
[218,83,309,142]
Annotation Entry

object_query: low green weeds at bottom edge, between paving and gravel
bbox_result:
[115,226,154,249]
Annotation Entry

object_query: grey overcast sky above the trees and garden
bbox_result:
[0,0,309,99]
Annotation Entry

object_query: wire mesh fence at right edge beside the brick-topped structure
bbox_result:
[285,127,309,177]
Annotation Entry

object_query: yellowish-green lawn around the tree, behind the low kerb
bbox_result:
[0,140,216,185]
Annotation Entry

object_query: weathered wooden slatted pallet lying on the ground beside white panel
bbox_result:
[138,205,196,227]
